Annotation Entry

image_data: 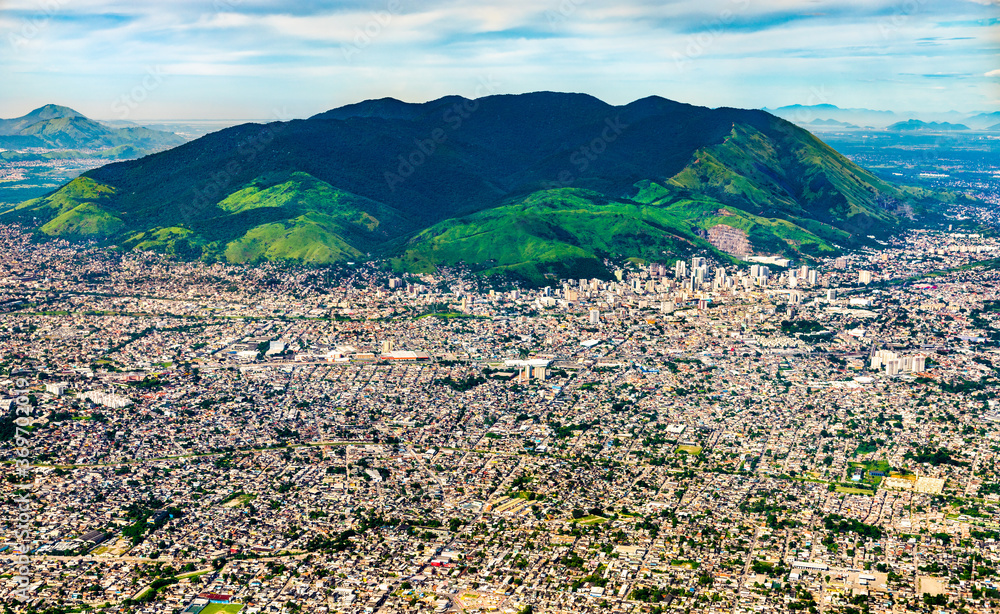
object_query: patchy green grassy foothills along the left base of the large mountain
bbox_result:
[0,173,409,263]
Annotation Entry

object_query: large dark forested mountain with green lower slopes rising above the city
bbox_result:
[0,92,960,282]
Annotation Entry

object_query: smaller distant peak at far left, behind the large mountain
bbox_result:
[0,104,185,158]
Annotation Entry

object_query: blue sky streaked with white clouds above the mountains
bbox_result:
[0,0,1000,121]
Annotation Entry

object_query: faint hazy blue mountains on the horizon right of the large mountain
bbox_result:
[764,104,1000,131]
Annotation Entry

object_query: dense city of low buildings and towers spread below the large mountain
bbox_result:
[0,218,1000,614]
